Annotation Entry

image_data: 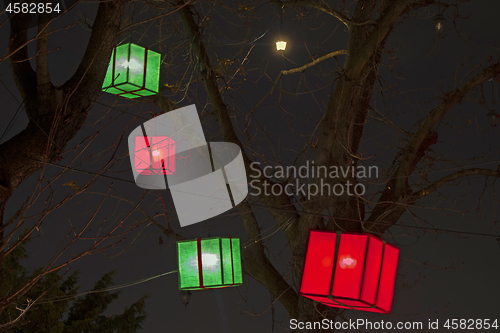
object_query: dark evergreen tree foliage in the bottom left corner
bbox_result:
[0,240,148,333]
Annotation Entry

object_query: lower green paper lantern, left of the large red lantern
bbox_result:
[177,237,243,290]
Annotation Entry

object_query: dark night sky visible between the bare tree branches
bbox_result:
[0,0,500,333]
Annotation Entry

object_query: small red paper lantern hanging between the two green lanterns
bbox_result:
[134,136,175,175]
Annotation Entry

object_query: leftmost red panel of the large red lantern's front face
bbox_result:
[300,231,337,295]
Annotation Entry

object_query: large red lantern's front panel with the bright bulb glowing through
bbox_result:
[332,234,368,299]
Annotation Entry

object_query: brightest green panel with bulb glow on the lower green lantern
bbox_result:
[201,238,222,287]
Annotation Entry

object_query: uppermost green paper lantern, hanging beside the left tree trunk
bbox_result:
[102,43,160,98]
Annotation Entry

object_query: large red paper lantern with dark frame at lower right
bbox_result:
[300,230,399,313]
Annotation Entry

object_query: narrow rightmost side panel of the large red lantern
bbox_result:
[376,243,399,313]
